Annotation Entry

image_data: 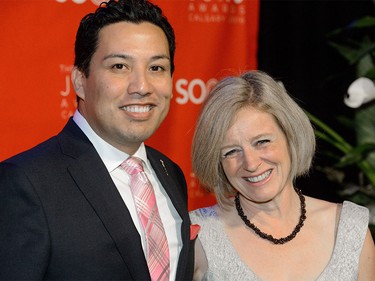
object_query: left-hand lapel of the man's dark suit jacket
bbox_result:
[60,121,150,280]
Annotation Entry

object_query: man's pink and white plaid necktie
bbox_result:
[121,157,170,281]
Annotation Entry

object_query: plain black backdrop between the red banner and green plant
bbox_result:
[258,0,375,202]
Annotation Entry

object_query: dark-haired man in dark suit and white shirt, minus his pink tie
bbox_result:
[0,0,194,280]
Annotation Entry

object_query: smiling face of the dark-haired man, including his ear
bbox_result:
[73,22,173,154]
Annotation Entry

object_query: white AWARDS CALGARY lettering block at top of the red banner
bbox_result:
[187,0,246,24]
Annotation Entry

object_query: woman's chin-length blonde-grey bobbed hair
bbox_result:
[192,71,315,205]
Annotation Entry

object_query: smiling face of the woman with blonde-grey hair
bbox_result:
[221,107,292,202]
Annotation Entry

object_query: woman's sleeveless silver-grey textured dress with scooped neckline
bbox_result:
[190,201,369,281]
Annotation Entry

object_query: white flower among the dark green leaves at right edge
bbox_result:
[344,77,375,108]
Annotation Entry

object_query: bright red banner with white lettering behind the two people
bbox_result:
[0,0,259,209]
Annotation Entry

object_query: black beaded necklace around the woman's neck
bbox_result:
[234,188,306,244]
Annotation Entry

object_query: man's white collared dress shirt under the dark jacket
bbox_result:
[73,110,182,281]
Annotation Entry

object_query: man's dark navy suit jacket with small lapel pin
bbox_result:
[0,120,194,280]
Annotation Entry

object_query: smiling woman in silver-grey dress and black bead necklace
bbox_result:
[190,71,375,281]
